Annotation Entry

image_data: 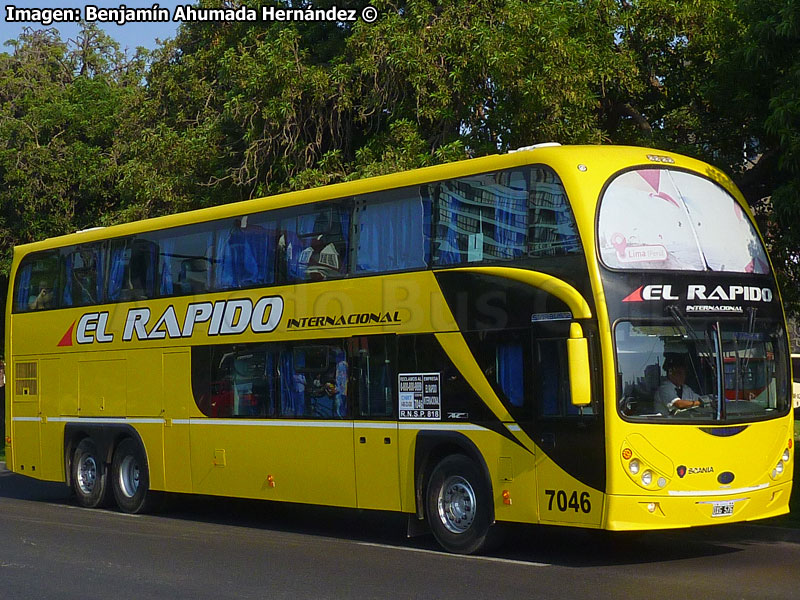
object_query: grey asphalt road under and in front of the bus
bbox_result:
[0,470,800,600]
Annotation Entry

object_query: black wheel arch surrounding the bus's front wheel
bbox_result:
[414,430,495,523]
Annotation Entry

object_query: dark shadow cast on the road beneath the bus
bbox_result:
[0,468,800,568]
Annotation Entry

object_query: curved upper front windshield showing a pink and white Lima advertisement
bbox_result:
[598,169,769,273]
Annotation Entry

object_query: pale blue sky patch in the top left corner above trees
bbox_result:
[0,0,182,53]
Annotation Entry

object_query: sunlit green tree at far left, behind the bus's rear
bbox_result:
[0,25,148,273]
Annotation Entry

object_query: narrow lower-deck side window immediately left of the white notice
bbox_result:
[349,335,397,418]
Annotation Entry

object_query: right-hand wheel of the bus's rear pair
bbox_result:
[111,438,155,514]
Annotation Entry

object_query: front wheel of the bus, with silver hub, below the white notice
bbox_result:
[425,454,492,554]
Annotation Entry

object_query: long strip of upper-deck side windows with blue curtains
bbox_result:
[13,165,583,312]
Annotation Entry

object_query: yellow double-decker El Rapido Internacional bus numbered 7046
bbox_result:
[5,144,793,553]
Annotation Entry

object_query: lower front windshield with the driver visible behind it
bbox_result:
[615,319,788,422]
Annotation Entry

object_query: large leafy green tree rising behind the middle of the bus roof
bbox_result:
[131,0,729,204]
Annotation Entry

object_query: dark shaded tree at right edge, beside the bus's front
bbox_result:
[707,0,800,316]
